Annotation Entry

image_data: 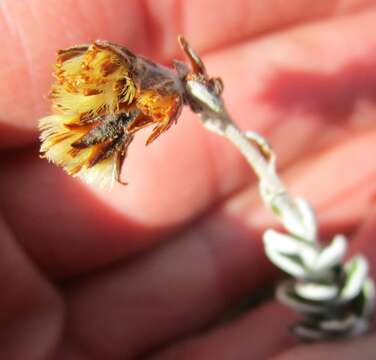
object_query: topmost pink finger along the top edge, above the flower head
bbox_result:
[0,0,374,146]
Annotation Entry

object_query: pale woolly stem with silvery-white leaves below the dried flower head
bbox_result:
[179,38,375,340]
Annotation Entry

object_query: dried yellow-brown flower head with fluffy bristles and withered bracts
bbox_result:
[39,41,195,187]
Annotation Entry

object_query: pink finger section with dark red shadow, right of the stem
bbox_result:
[214,11,376,165]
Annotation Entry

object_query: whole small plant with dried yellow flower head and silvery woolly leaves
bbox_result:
[39,37,375,340]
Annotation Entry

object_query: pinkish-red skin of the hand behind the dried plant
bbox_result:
[0,0,376,360]
